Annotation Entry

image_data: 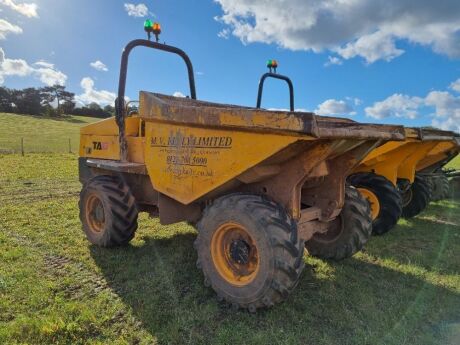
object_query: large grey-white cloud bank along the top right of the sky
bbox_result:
[216,0,460,63]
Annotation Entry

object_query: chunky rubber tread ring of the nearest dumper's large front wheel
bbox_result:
[196,193,304,312]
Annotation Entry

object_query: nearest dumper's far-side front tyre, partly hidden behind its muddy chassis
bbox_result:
[305,186,372,260]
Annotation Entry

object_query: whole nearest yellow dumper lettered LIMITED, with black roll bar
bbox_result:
[79,34,404,312]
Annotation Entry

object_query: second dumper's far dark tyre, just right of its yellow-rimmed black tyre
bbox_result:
[401,176,431,218]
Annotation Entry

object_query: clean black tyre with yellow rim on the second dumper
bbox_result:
[349,173,402,235]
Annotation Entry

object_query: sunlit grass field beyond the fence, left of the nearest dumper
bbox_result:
[0,113,98,153]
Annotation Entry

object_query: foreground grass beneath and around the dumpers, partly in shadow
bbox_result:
[0,154,460,345]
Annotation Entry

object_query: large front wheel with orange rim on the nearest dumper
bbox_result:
[195,194,304,312]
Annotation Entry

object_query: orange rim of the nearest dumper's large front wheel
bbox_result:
[211,223,260,286]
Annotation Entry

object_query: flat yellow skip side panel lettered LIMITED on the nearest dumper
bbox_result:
[145,122,298,204]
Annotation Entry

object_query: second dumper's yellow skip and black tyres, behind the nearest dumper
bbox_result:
[349,128,458,234]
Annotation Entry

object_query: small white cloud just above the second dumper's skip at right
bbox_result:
[365,94,423,119]
